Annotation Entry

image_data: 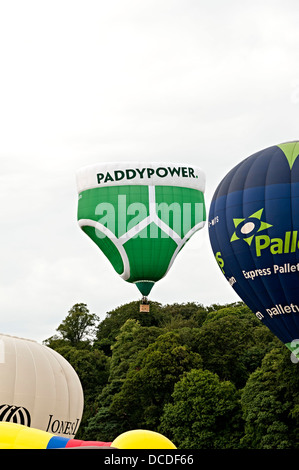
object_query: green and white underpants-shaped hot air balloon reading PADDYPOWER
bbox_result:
[77,162,206,296]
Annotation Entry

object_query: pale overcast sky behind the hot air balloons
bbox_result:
[0,0,299,341]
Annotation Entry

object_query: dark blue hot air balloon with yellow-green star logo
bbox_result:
[209,141,299,358]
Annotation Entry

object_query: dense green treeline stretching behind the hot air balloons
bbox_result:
[45,302,299,449]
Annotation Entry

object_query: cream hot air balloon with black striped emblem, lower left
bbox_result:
[0,334,84,438]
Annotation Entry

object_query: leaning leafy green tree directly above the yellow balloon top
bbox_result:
[110,332,201,430]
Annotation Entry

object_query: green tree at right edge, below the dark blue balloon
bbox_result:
[241,345,299,449]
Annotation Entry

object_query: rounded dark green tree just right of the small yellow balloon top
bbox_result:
[159,370,243,449]
